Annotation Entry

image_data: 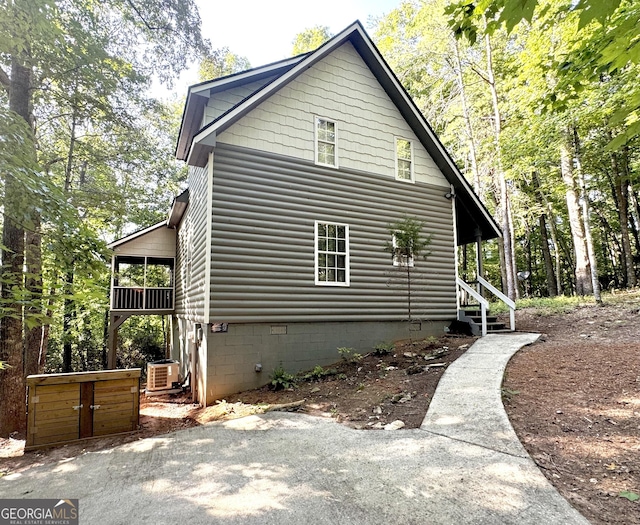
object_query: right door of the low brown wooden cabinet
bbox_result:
[93,378,139,436]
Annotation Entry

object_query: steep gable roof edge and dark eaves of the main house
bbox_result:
[176,20,501,244]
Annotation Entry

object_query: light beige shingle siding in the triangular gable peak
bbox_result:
[214,43,447,186]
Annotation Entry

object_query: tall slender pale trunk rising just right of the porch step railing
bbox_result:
[485,33,517,300]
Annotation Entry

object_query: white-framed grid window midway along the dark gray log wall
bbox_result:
[315,221,349,286]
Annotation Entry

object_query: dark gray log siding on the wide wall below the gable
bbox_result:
[210,144,456,322]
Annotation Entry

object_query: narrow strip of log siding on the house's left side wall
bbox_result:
[176,167,211,322]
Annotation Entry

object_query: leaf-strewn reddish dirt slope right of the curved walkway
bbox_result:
[503,295,640,525]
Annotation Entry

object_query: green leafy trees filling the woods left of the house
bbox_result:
[0,0,207,435]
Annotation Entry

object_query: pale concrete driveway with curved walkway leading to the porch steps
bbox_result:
[0,334,587,525]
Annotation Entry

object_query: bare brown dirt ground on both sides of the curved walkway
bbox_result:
[0,293,640,525]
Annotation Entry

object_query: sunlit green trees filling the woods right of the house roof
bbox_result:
[374,0,640,302]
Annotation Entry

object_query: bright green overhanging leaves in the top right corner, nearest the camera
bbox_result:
[446,0,640,149]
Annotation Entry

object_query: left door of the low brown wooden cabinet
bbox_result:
[27,383,82,445]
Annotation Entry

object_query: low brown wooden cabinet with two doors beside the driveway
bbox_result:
[25,368,140,450]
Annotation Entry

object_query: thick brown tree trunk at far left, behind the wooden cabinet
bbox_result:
[0,56,31,437]
